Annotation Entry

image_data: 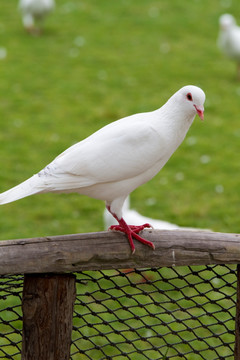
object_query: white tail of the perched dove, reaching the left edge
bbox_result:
[0,175,43,205]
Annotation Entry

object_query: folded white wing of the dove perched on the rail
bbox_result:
[40,113,168,189]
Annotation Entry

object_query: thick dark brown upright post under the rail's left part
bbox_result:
[22,274,76,360]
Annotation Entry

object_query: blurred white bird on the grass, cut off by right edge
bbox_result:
[217,14,240,79]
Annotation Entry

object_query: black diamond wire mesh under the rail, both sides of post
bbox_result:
[0,265,236,360]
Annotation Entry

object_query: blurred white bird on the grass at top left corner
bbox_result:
[19,0,55,35]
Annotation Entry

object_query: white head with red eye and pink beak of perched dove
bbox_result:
[173,85,205,120]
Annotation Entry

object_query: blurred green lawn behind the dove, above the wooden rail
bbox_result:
[0,0,240,239]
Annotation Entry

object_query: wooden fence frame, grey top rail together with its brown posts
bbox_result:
[0,230,240,360]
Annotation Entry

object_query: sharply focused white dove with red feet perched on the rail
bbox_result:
[0,85,205,253]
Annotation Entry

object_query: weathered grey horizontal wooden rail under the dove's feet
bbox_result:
[0,230,240,275]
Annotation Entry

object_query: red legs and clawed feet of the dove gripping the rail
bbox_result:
[107,206,155,254]
